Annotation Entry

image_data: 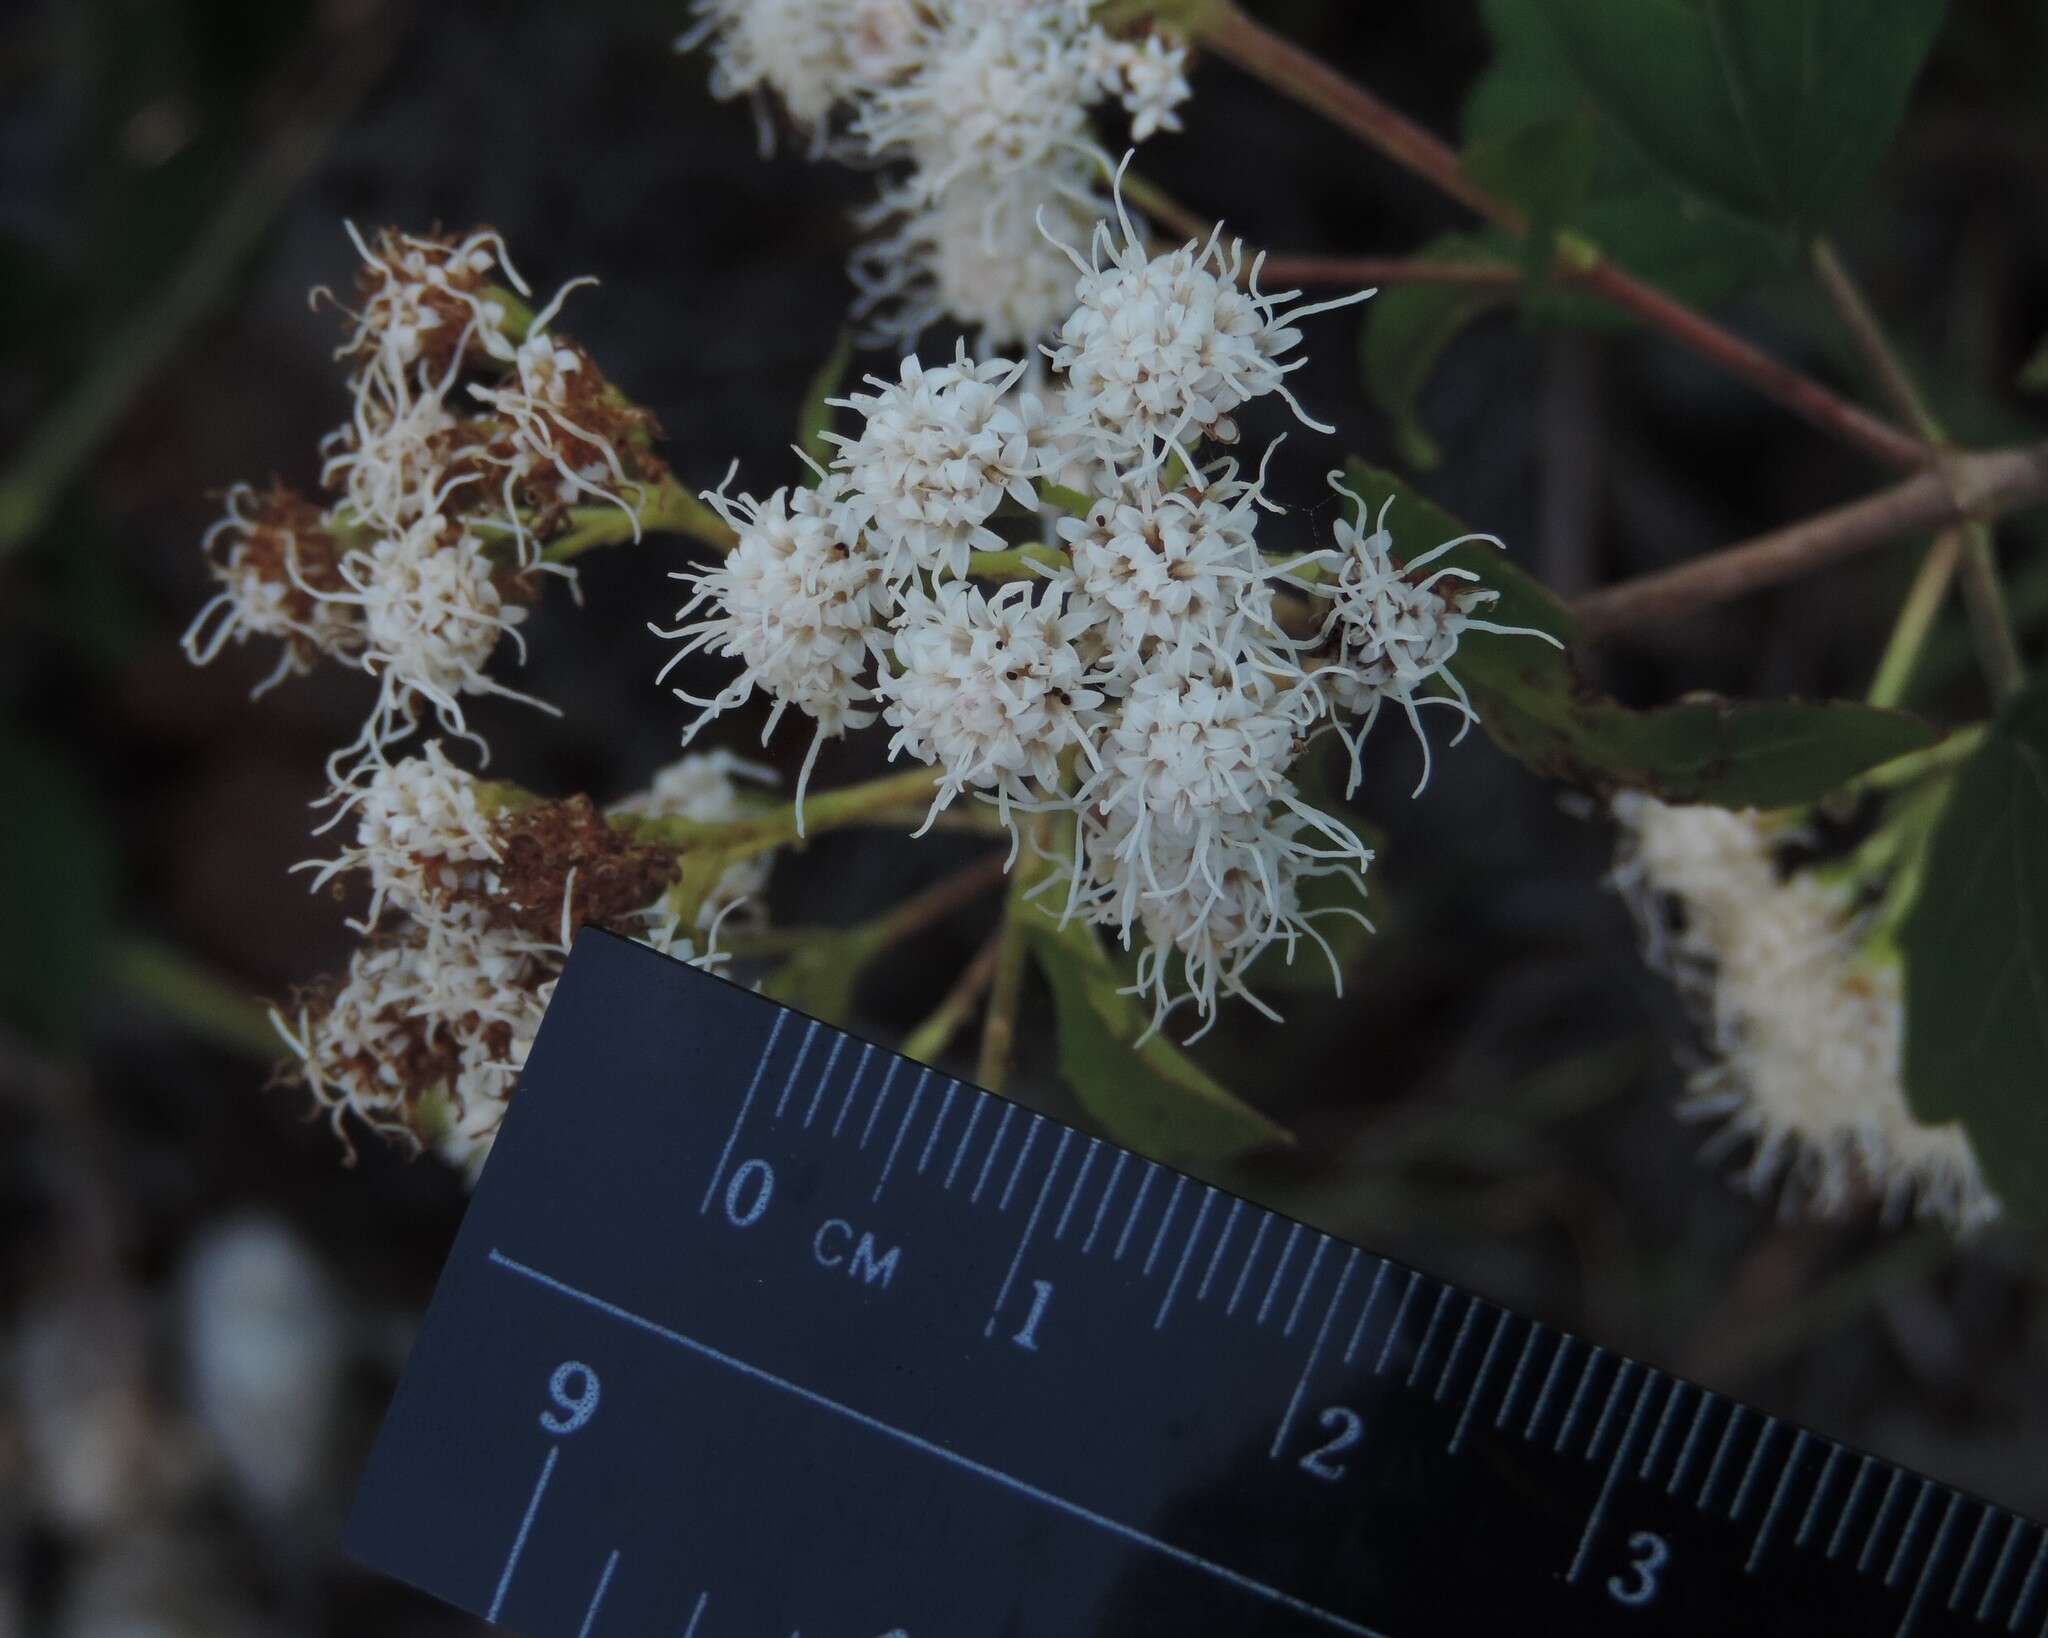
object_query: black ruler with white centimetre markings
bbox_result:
[348,932,2048,1638]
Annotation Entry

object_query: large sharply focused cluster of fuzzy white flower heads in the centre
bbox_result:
[657,207,1548,1020]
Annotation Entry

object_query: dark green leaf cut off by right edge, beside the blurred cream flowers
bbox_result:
[1901,684,2048,1222]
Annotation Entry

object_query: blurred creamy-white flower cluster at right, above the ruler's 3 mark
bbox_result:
[1614,794,1999,1226]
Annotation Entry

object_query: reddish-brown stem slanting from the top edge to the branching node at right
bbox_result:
[1200,0,1929,469]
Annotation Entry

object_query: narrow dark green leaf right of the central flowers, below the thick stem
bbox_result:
[1348,461,1939,807]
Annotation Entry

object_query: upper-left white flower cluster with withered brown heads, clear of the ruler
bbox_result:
[184,227,659,782]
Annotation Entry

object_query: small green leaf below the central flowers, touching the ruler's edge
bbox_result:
[1018,905,1292,1165]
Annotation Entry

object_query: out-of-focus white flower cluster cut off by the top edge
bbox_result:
[678,0,1190,348]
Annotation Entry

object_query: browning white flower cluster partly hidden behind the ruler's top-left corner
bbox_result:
[276,741,749,1173]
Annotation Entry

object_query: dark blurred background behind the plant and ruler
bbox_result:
[0,0,2048,1638]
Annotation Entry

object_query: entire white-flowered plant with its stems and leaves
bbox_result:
[186,0,2048,1229]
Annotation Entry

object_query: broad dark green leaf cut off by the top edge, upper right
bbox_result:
[1544,0,1944,233]
